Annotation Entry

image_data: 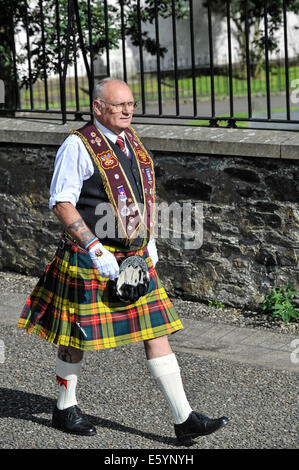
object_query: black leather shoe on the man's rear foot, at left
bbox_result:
[52,405,97,436]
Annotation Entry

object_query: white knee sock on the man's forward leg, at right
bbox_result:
[147,354,192,424]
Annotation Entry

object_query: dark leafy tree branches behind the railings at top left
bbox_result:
[0,0,188,112]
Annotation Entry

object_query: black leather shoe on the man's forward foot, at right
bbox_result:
[174,411,228,443]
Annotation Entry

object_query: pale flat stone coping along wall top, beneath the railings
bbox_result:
[0,118,299,159]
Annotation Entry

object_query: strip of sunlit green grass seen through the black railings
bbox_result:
[21,66,299,119]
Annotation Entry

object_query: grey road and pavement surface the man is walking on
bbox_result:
[0,292,299,450]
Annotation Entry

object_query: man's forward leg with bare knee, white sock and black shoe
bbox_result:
[144,336,228,445]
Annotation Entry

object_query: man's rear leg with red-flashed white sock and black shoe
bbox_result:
[52,346,96,436]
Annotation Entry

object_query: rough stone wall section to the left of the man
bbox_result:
[0,144,62,275]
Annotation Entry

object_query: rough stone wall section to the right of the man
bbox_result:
[156,153,299,309]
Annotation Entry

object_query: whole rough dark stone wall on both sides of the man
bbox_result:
[0,119,299,309]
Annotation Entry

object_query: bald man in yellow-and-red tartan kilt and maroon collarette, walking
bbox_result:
[18,78,228,443]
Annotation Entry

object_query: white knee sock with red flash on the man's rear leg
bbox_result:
[56,357,82,410]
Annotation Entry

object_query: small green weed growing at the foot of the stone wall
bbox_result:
[263,282,299,323]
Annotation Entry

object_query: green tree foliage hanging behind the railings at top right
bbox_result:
[204,0,299,76]
